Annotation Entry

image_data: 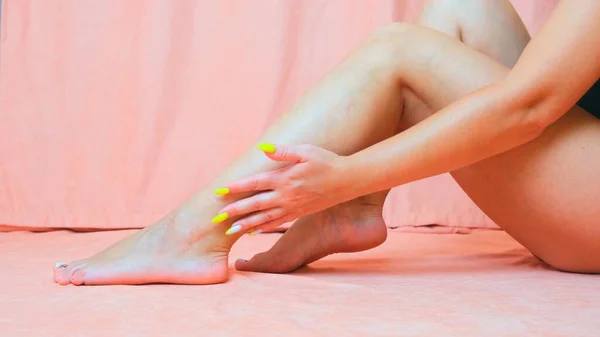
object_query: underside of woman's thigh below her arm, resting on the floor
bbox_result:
[451,107,600,272]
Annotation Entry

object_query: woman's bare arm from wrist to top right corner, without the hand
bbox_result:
[345,0,600,194]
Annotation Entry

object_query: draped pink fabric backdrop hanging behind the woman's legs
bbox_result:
[0,0,556,228]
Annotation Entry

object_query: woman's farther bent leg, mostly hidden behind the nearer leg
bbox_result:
[236,0,530,273]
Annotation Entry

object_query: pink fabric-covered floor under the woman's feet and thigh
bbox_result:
[0,230,600,337]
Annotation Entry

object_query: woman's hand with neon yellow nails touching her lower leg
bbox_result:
[213,144,351,235]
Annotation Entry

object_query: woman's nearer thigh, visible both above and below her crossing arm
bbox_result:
[390,27,600,272]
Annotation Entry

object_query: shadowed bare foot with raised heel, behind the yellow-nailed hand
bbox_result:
[235,193,387,273]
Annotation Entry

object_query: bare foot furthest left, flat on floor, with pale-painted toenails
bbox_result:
[54,213,233,285]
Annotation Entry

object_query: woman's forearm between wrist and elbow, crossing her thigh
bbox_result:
[345,83,544,195]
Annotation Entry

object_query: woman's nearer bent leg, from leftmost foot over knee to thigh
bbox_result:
[55,0,600,284]
